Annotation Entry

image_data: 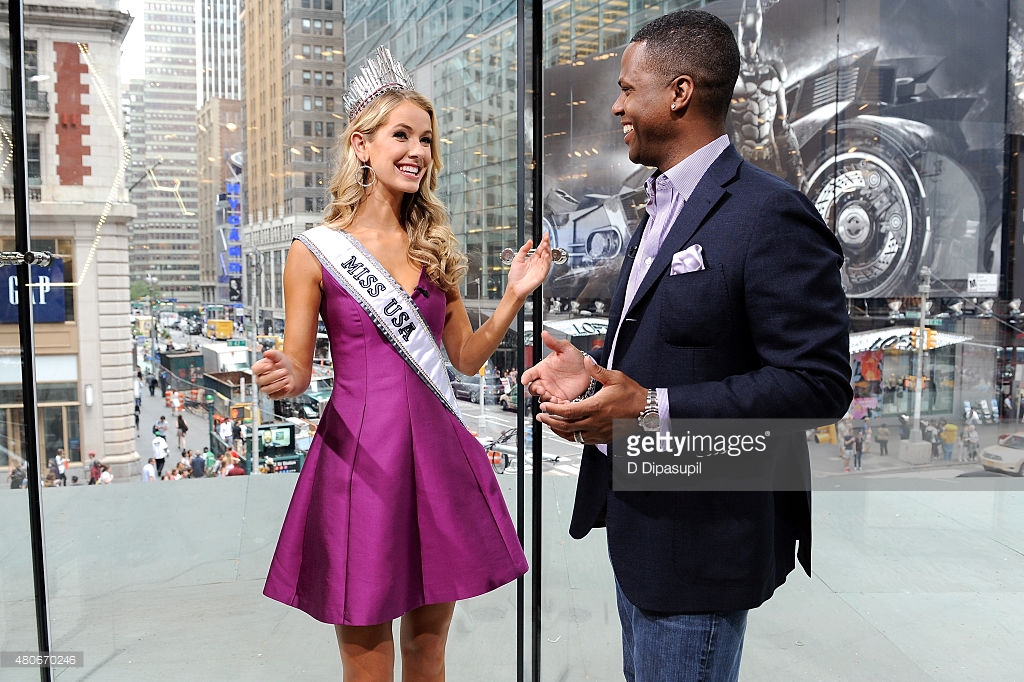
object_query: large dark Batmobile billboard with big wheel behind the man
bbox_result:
[544,0,1008,303]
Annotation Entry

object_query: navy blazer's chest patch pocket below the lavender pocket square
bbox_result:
[655,263,730,348]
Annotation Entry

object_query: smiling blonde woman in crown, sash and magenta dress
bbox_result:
[253,49,551,680]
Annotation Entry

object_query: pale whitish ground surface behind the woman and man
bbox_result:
[0,474,1024,682]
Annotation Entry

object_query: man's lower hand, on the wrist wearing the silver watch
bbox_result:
[537,353,647,443]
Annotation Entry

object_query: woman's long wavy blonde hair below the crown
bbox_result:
[324,90,466,292]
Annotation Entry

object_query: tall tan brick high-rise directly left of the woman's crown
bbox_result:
[242,0,345,333]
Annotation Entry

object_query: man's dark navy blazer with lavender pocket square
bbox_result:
[569,146,852,613]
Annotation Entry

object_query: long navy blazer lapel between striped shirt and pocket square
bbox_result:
[615,146,741,317]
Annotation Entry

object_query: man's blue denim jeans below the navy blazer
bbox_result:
[615,580,746,682]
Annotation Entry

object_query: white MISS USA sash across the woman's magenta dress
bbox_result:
[295,225,465,423]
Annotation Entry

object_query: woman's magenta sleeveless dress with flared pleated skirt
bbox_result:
[263,258,527,626]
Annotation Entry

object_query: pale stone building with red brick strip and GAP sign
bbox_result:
[0,0,137,469]
